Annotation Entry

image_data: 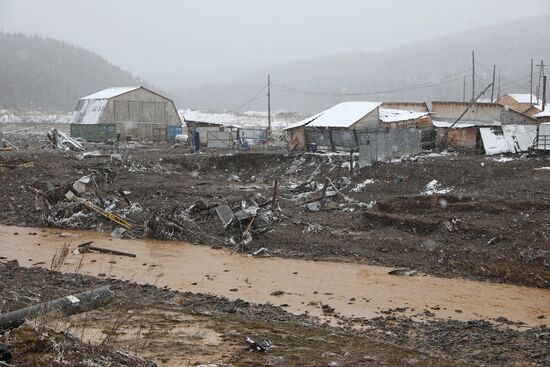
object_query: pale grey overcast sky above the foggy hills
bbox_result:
[0,0,550,89]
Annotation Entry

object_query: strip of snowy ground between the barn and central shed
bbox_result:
[178,109,303,129]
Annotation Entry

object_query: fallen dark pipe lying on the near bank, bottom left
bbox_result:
[0,286,115,332]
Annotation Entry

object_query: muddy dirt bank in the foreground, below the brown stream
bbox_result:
[0,262,550,366]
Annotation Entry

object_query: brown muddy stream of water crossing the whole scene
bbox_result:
[0,226,550,326]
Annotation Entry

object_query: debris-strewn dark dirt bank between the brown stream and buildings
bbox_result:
[0,125,550,288]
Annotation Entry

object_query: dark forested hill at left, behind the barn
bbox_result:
[0,32,142,111]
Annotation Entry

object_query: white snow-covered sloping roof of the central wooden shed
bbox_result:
[287,102,382,129]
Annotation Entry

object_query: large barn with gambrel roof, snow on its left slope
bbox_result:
[71,87,182,142]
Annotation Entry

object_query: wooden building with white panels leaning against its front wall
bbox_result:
[432,102,537,154]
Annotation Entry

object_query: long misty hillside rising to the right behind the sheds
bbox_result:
[175,15,550,112]
